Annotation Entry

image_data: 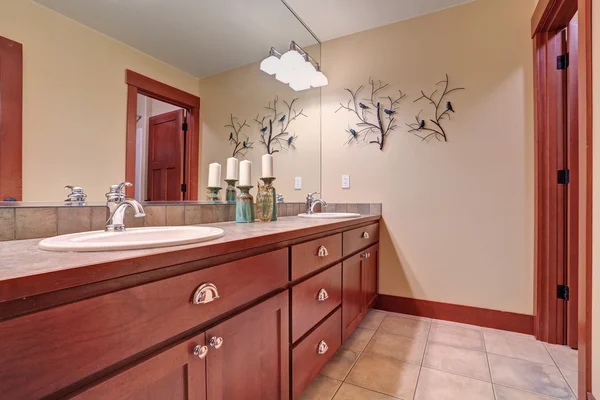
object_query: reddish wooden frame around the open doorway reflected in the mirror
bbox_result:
[125,70,201,200]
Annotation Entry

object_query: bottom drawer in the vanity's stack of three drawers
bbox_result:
[292,309,342,399]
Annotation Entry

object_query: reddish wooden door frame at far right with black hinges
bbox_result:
[531,0,592,400]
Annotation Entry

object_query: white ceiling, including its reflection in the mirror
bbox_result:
[34,0,472,77]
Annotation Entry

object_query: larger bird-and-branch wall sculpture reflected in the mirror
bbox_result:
[254,96,307,154]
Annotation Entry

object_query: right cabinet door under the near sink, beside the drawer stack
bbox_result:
[206,291,290,400]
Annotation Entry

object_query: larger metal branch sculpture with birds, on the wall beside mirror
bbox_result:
[336,77,406,150]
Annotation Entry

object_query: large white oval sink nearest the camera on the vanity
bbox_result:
[39,226,224,252]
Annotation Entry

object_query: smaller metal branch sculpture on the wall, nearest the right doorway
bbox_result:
[406,74,465,142]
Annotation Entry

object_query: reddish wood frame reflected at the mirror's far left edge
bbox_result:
[0,36,23,201]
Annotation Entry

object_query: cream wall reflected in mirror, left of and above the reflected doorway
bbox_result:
[0,0,198,201]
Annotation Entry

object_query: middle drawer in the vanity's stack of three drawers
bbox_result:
[292,264,342,343]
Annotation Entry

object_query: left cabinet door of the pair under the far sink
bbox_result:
[342,253,365,341]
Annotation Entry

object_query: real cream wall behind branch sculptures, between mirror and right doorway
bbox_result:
[322,0,533,314]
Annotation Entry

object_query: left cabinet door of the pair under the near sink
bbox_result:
[74,333,206,400]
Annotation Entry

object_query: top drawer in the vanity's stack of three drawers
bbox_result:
[292,233,342,280]
